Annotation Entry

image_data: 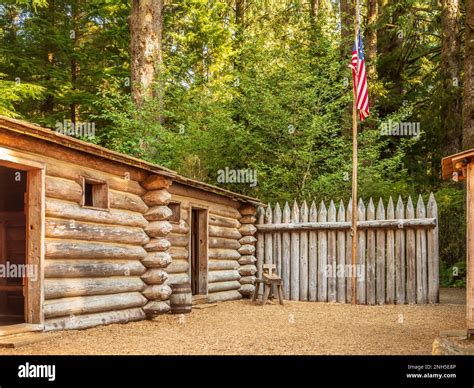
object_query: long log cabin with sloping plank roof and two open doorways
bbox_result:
[0,116,260,331]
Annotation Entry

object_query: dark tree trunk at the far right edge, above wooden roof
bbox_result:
[462,0,474,149]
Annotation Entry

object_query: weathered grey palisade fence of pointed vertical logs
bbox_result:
[257,194,439,304]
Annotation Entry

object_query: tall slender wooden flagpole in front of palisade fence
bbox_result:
[351,0,359,304]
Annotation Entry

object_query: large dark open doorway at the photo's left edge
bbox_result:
[0,166,27,325]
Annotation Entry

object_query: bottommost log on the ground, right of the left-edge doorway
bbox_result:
[44,308,146,331]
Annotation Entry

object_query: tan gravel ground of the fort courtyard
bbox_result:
[0,290,465,355]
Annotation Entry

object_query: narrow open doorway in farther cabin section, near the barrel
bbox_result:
[190,208,208,295]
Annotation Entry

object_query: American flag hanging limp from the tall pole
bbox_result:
[349,30,369,121]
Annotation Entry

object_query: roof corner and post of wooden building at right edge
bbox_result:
[442,150,474,338]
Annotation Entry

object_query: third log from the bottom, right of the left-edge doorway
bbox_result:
[44,276,145,299]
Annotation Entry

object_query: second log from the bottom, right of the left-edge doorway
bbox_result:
[44,292,148,319]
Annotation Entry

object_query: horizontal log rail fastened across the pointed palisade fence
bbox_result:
[257,218,436,232]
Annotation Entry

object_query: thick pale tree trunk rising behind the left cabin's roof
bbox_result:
[130,0,163,107]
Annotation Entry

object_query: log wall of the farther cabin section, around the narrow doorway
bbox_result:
[166,182,256,302]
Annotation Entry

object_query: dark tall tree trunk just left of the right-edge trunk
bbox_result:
[440,0,462,155]
